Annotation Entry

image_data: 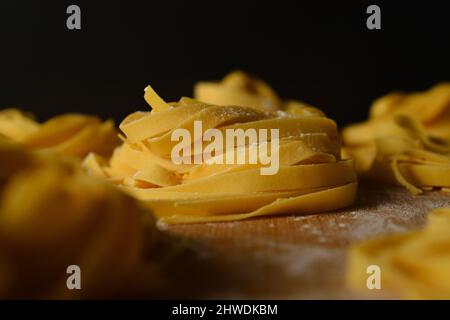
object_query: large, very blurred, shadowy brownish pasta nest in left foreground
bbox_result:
[0,127,157,298]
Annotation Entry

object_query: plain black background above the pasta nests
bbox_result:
[0,0,450,125]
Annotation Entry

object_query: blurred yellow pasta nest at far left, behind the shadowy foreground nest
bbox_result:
[0,109,119,158]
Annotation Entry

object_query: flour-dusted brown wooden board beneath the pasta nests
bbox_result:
[163,182,450,299]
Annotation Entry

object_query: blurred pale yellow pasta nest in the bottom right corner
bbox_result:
[348,208,450,299]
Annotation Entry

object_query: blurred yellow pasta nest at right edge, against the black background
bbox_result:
[342,83,450,194]
